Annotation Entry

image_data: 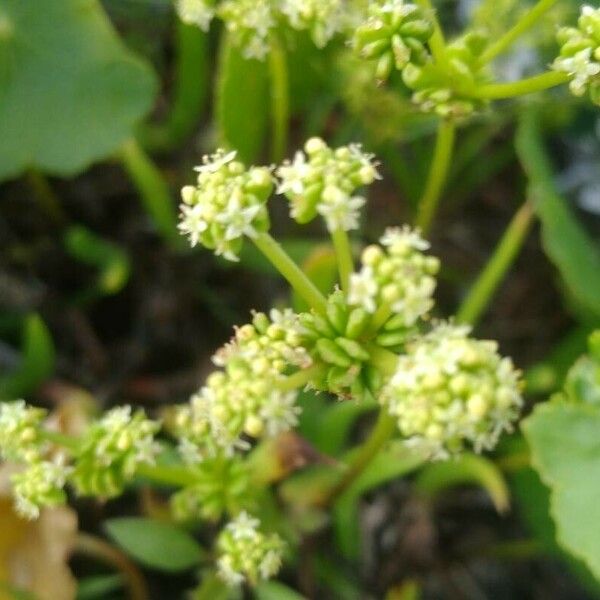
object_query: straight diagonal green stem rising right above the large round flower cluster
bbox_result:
[456,202,533,325]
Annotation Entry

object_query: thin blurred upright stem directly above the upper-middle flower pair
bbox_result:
[269,36,290,162]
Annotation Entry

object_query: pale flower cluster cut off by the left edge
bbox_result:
[0,400,46,463]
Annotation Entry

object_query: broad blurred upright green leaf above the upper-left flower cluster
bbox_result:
[216,34,270,163]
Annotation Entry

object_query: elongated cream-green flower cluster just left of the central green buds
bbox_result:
[176,310,310,463]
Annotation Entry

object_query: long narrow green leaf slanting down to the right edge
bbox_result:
[516,110,600,318]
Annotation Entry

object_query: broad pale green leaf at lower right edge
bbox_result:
[522,398,600,578]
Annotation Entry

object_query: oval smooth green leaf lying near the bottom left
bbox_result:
[104,517,205,572]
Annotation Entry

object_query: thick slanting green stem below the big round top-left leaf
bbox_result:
[119,139,180,246]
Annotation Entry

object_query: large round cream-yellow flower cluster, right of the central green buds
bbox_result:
[380,324,522,459]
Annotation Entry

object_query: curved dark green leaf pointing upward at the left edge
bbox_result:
[0,313,55,399]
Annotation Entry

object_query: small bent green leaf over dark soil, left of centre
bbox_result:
[64,225,131,296]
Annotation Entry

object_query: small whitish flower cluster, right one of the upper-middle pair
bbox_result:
[277,138,379,231]
